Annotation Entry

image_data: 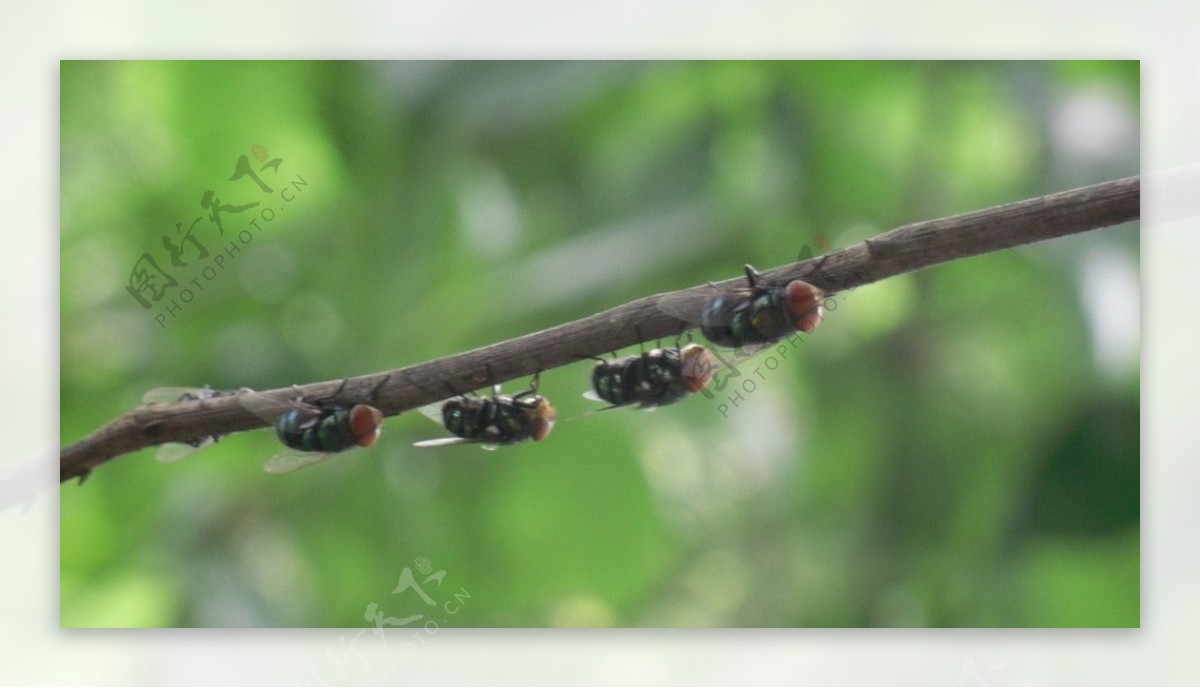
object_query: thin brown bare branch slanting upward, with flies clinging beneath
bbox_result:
[60,177,1141,480]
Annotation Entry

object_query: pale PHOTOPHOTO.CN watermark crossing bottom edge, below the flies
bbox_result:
[299,557,472,686]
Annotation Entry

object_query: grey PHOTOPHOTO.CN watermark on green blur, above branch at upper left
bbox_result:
[125,144,308,328]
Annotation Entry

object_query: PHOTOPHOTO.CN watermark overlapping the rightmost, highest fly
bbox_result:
[701,235,874,418]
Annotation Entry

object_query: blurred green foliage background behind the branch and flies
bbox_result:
[61,61,1139,628]
